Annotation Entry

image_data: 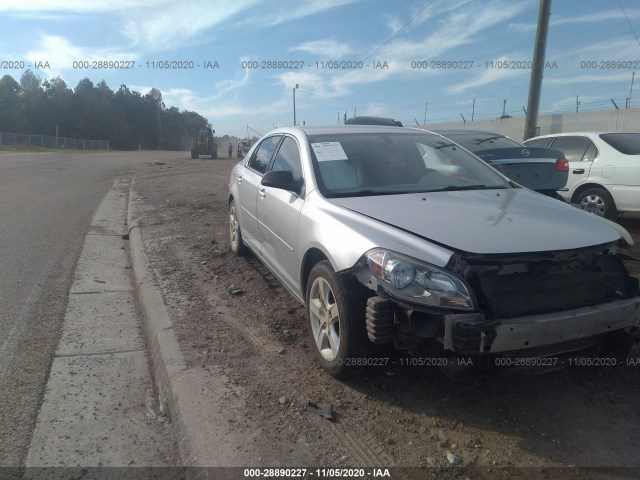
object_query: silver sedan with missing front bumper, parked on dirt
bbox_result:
[228,125,640,377]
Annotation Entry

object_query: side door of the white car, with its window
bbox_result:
[549,135,598,201]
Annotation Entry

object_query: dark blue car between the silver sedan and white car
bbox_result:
[434,129,569,200]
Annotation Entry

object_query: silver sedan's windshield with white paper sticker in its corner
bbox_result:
[309,133,509,197]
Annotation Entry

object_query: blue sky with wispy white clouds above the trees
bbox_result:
[0,0,640,137]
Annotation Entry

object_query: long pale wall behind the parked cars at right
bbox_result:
[420,108,640,140]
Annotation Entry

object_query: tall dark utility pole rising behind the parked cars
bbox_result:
[524,0,551,140]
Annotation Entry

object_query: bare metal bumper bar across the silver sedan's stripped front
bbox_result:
[443,297,640,355]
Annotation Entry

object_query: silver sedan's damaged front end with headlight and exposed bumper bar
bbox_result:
[355,244,640,374]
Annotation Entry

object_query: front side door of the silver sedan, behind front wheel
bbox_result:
[256,136,304,295]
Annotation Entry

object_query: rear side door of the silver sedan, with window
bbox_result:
[236,135,282,252]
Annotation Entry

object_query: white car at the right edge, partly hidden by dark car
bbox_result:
[525,132,640,219]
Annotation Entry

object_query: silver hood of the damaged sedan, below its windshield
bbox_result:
[331,189,622,254]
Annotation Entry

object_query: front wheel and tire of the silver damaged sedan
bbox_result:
[306,260,372,378]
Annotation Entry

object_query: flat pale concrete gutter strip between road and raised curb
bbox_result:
[25,179,177,468]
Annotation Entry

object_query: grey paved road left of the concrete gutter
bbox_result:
[0,152,175,466]
